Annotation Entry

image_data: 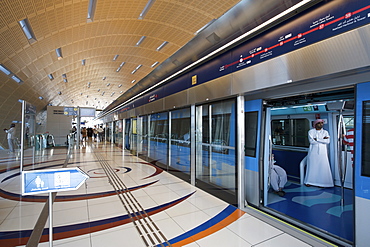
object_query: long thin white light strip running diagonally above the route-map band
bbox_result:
[103,0,314,116]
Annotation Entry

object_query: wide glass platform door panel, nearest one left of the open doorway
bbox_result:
[195,100,237,205]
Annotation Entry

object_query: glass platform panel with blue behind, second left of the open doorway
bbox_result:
[170,108,191,174]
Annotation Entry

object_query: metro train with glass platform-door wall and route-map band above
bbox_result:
[101,0,370,246]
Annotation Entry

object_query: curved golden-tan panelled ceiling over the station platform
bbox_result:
[0,0,239,133]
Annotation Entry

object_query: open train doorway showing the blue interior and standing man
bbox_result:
[262,89,355,244]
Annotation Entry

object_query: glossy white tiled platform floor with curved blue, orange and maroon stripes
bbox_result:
[0,142,330,247]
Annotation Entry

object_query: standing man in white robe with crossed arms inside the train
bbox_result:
[304,119,334,187]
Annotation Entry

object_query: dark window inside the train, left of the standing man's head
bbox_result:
[271,118,310,147]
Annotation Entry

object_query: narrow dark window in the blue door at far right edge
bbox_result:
[361,101,370,177]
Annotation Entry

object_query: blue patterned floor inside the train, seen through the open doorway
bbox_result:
[267,182,353,241]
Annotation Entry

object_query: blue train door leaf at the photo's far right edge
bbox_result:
[354,82,370,246]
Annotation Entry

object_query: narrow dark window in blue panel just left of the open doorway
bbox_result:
[245,111,258,157]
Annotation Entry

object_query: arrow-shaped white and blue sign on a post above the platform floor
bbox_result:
[22,167,89,195]
